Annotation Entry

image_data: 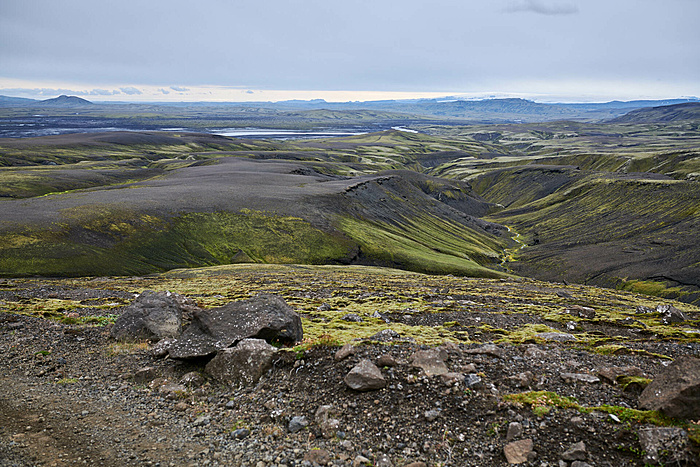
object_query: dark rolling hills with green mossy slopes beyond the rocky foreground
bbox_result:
[0,104,700,308]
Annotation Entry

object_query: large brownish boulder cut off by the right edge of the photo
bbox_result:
[639,357,700,420]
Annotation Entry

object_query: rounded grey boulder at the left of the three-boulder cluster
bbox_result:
[110,290,200,341]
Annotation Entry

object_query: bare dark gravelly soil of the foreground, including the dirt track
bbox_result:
[0,279,700,466]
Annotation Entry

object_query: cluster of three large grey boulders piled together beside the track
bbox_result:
[111,291,303,386]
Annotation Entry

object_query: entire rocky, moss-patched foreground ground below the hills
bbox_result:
[0,266,700,467]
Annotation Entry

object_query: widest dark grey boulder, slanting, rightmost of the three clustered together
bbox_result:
[168,295,304,358]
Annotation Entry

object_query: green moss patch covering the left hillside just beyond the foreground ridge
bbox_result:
[0,211,355,276]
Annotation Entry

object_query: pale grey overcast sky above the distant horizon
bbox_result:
[0,0,700,102]
